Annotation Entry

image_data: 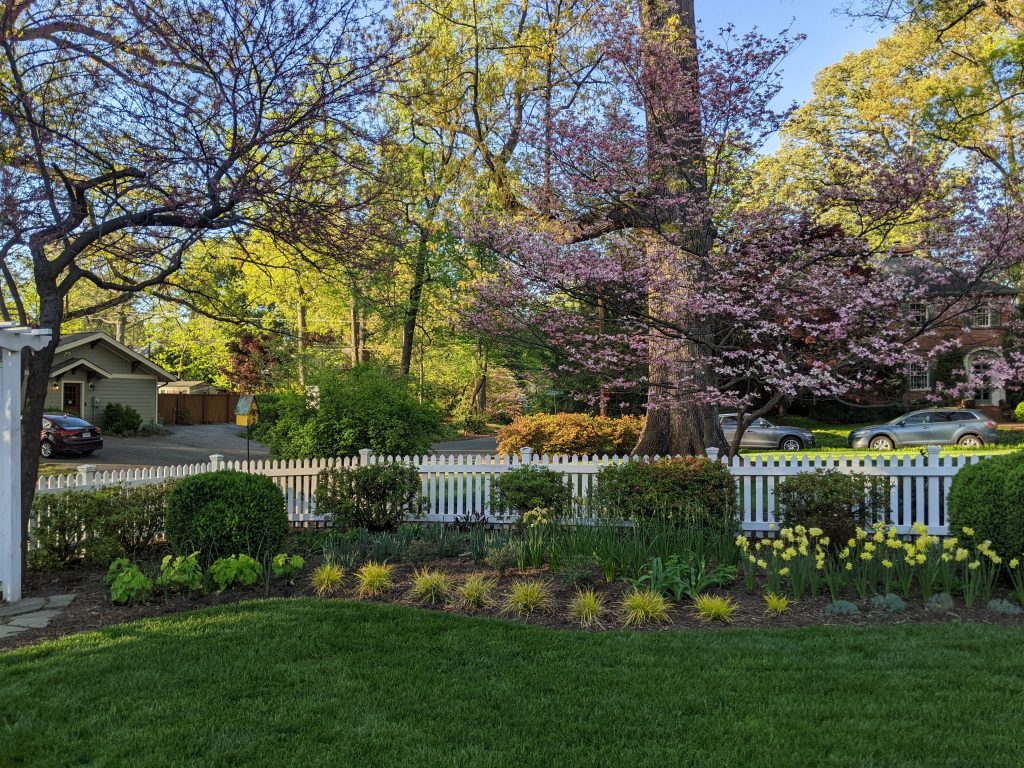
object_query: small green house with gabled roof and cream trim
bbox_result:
[46,331,176,427]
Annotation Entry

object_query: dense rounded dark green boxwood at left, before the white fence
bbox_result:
[167,470,288,563]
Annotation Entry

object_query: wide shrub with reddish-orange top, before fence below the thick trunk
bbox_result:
[590,456,736,526]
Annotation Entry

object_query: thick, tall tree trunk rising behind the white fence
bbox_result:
[635,0,726,456]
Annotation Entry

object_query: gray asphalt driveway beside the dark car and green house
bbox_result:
[45,424,270,469]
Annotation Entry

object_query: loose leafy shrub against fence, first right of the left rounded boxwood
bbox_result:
[316,462,421,531]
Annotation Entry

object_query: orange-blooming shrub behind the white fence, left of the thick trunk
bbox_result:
[498,414,643,455]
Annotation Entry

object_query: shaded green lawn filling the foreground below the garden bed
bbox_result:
[0,600,1024,768]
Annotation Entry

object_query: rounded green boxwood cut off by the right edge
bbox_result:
[949,453,1024,558]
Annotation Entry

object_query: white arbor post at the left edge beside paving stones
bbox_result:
[0,323,50,602]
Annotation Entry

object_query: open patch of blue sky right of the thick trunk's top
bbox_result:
[696,0,885,109]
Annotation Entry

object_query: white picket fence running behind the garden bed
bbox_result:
[37,446,987,535]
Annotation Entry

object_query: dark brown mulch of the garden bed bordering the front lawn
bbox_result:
[0,556,1024,649]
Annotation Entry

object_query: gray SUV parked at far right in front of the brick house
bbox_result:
[850,409,999,451]
